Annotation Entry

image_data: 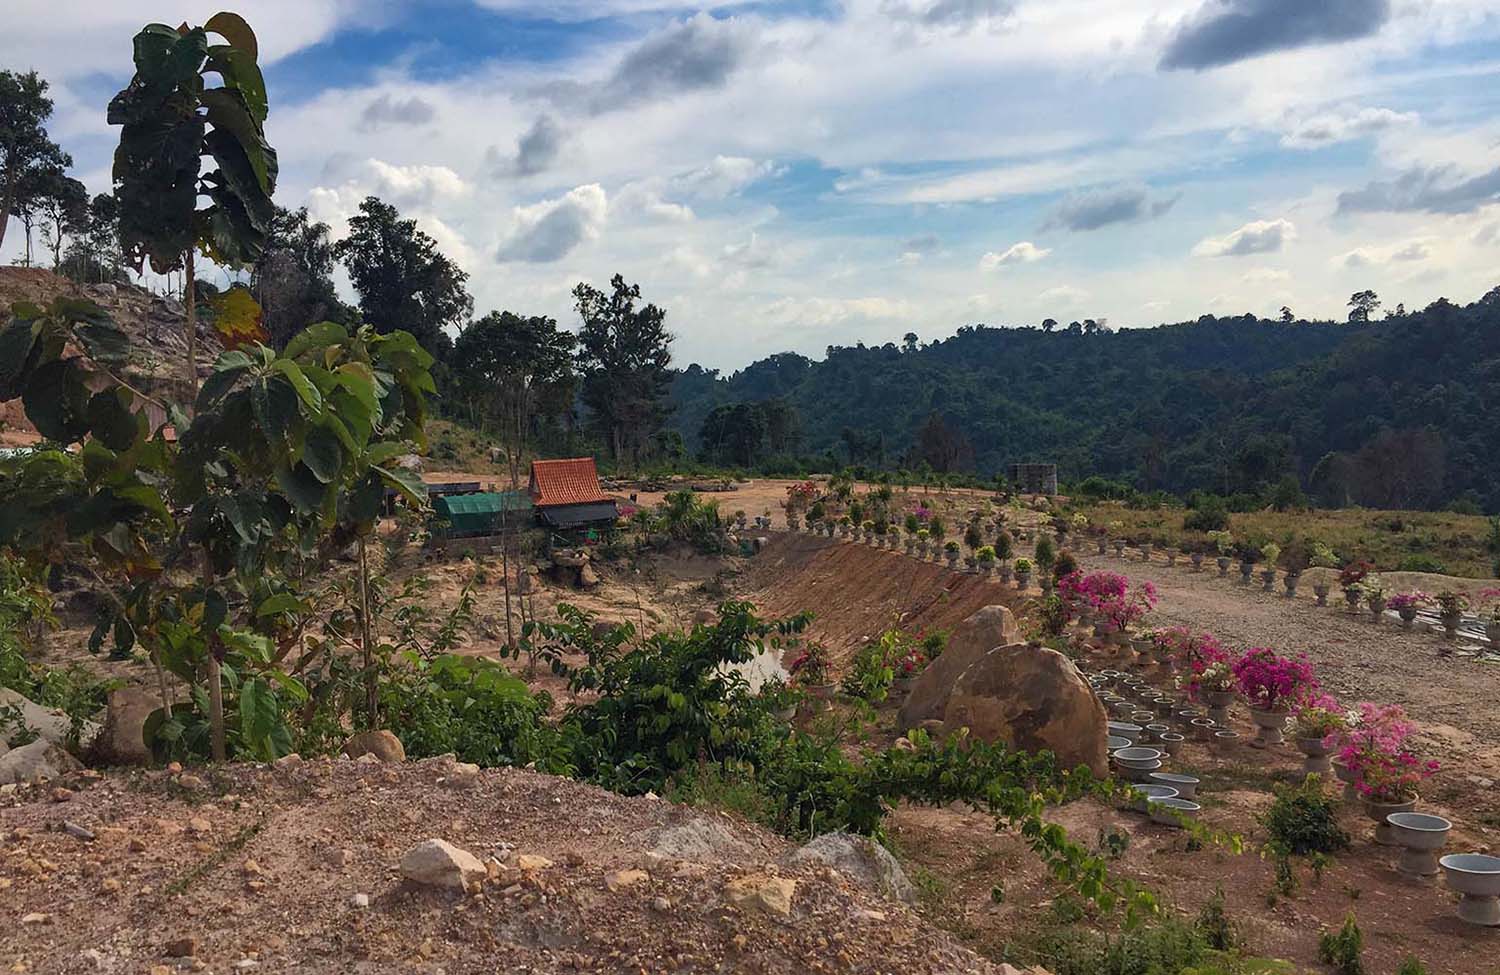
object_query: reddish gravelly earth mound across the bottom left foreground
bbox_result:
[0,759,998,975]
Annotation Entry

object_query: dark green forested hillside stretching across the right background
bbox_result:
[672,288,1500,510]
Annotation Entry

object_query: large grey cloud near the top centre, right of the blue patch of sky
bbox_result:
[564,12,758,114]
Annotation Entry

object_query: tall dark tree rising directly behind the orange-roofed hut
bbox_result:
[573,275,672,462]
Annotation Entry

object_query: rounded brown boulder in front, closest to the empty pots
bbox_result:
[944,644,1109,776]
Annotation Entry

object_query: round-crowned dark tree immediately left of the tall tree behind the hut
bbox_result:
[453,312,578,486]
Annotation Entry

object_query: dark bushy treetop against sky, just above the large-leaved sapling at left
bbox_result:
[333,197,474,360]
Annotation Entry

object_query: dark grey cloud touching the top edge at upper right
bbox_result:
[1161,0,1391,71]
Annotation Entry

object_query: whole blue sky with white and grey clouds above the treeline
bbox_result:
[0,0,1500,369]
